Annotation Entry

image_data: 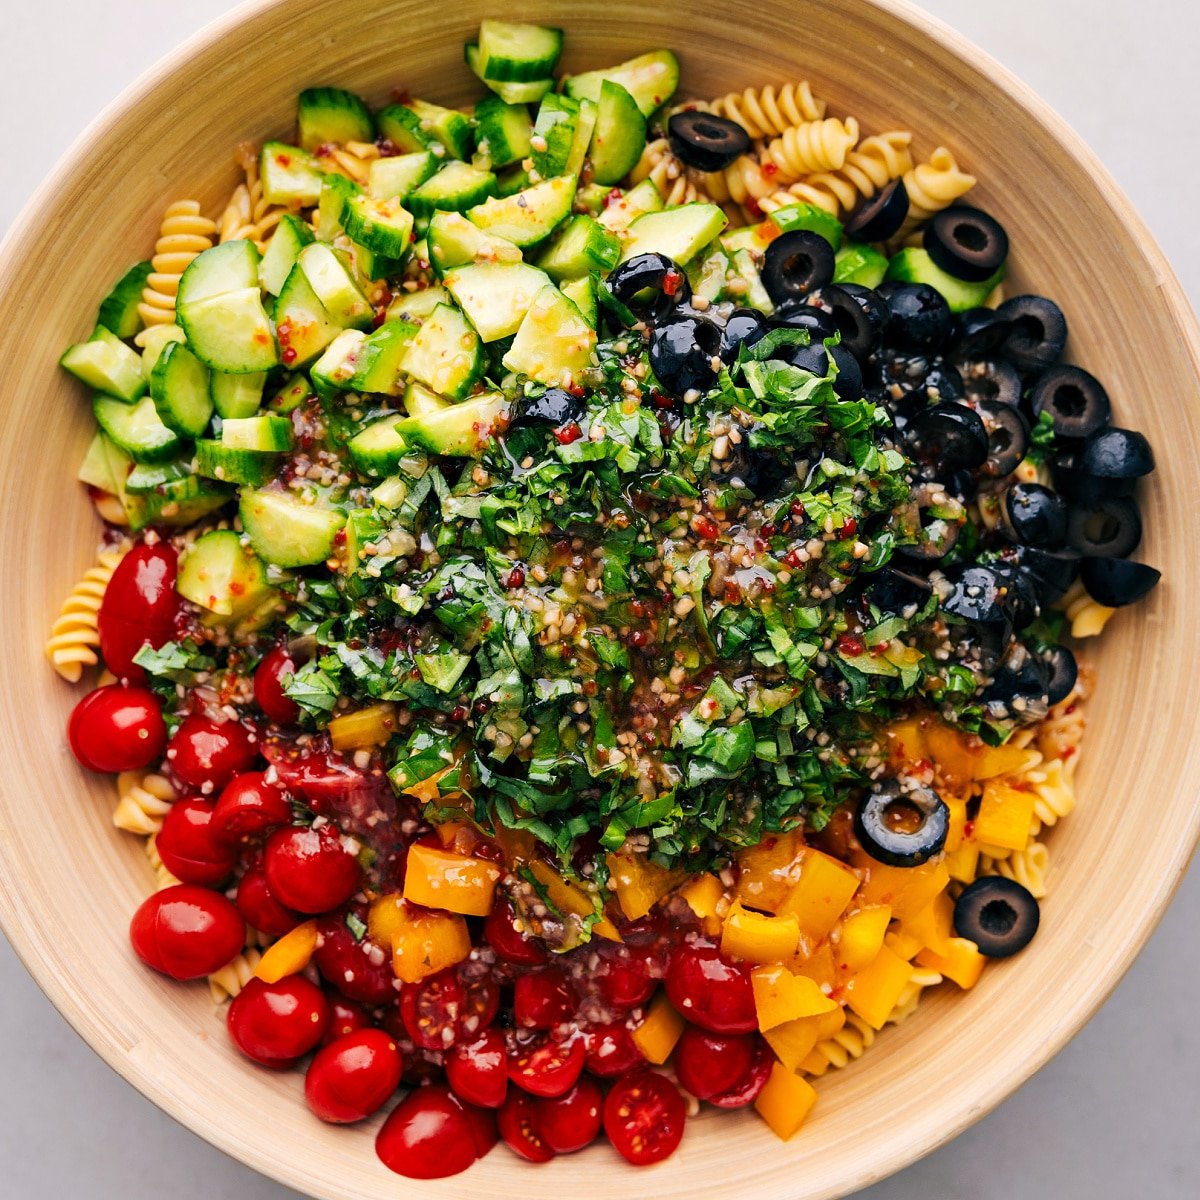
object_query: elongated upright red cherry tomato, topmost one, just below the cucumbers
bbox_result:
[96,542,182,683]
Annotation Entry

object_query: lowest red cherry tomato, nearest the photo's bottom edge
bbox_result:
[376,1084,481,1180]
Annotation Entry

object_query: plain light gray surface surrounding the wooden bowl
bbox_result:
[0,0,1200,1200]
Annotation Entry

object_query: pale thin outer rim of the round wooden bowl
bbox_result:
[0,0,1200,1200]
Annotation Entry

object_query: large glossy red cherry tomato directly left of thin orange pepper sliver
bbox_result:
[130,883,246,979]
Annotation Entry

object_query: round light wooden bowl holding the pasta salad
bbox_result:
[0,0,1200,1200]
